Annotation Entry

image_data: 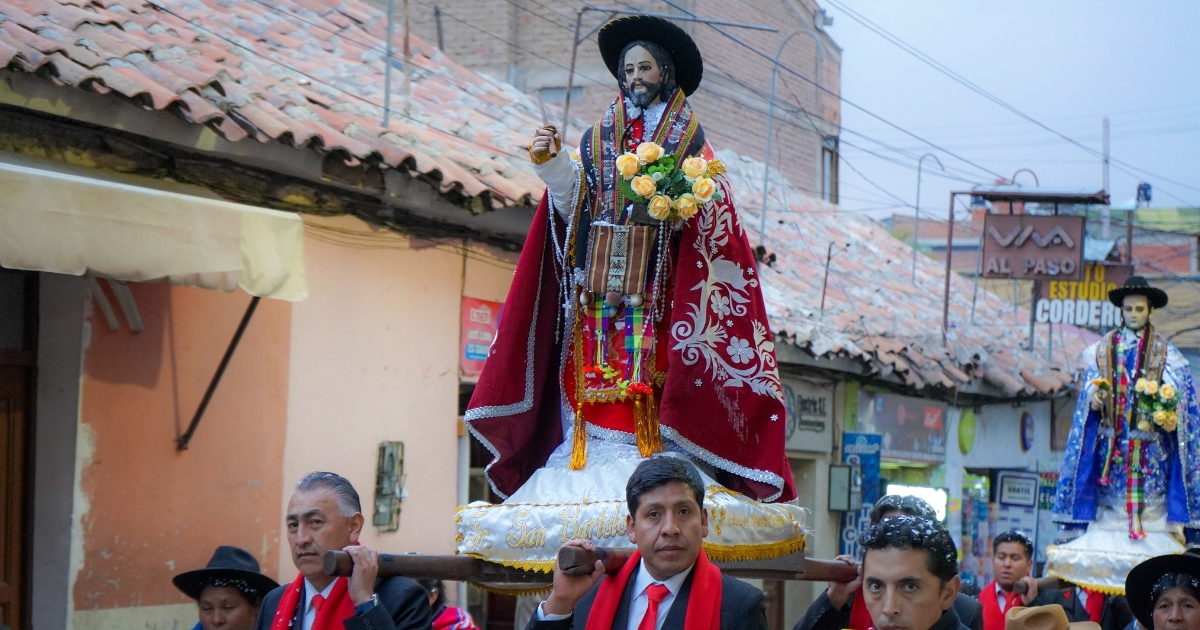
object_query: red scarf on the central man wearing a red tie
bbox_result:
[583,548,721,630]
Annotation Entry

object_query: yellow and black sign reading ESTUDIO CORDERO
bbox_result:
[1033,264,1133,331]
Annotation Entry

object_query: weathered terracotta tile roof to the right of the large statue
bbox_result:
[718,151,1098,396]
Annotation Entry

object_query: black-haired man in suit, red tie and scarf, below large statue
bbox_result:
[527,455,767,630]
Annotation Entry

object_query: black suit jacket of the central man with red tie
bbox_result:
[526,571,767,630]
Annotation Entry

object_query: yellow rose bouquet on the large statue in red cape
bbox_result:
[617,142,724,222]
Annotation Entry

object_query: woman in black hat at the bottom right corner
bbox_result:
[1126,548,1200,630]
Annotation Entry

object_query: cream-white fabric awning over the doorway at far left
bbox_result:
[0,154,308,301]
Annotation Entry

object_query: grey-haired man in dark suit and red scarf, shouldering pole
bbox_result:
[254,473,430,630]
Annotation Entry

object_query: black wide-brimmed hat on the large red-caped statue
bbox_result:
[596,16,704,96]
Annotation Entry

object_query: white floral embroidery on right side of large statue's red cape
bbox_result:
[671,178,784,402]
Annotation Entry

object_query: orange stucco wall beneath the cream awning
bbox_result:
[72,283,292,630]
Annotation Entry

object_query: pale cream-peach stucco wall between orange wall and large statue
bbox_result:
[276,216,514,578]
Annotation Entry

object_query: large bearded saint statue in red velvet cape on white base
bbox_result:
[456,16,805,570]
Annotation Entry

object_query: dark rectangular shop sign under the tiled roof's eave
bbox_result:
[858,390,946,460]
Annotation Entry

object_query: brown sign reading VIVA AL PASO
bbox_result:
[983,215,1085,280]
